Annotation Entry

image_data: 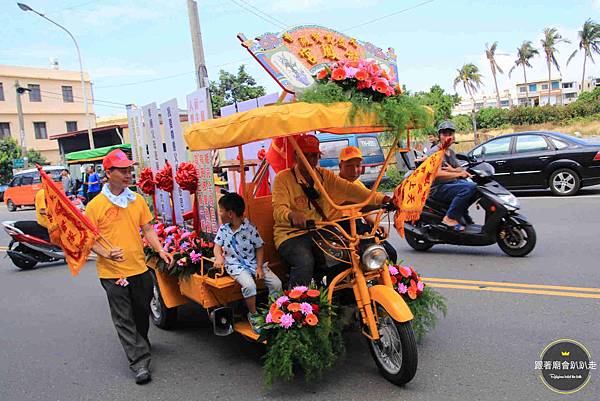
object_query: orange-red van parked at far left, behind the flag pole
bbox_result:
[4,166,64,212]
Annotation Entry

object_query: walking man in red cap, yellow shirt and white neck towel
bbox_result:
[85,149,172,384]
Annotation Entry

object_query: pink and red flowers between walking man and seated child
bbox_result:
[144,223,214,278]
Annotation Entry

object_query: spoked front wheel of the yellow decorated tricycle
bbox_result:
[367,306,418,386]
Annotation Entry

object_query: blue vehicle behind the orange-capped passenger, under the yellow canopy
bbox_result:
[317,134,386,187]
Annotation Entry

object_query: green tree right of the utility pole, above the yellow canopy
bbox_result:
[209,64,265,117]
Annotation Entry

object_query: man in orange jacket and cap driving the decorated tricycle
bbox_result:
[272,135,389,286]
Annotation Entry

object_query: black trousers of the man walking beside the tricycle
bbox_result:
[100,271,153,371]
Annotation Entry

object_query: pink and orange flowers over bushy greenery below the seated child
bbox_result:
[256,285,344,386]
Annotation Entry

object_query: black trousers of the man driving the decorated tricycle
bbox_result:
[277,233,326,287]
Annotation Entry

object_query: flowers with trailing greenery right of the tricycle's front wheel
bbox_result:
[388,265,448,342]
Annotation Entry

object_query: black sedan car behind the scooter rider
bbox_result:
[468,131,600,196]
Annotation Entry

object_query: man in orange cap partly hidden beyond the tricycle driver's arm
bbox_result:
[335,146,398,263]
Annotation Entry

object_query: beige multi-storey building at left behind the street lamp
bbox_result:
[0,63,96,163]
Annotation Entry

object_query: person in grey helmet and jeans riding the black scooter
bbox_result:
[427,120,477,231]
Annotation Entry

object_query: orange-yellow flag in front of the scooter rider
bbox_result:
[394,141,452,238]
